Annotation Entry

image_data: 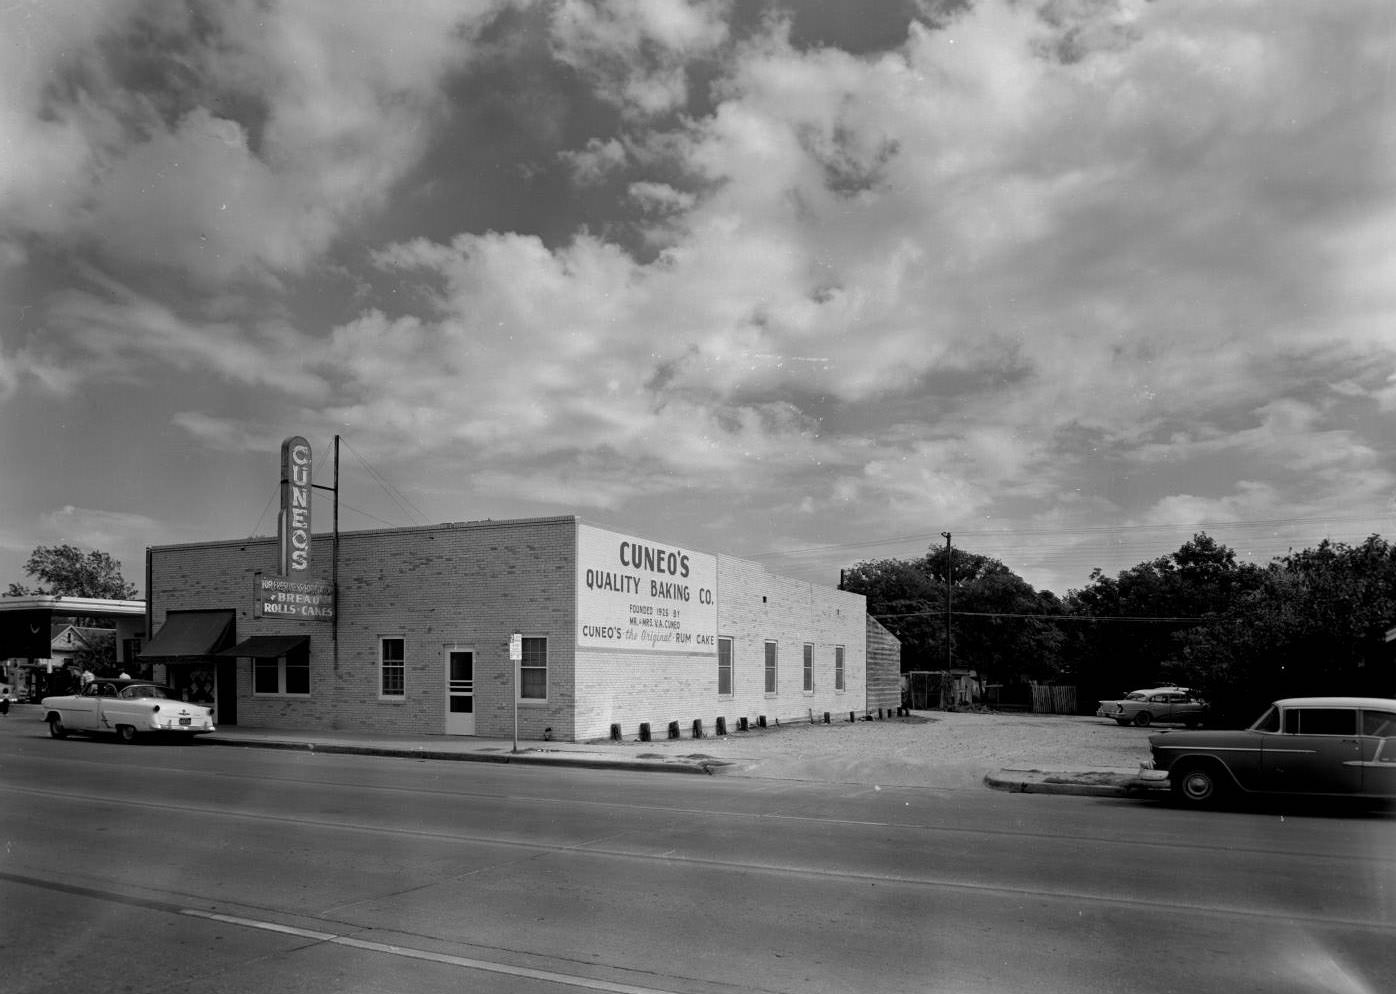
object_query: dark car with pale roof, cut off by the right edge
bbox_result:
[1141,697,1396,806]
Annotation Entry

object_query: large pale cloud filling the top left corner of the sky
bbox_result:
[0,0,498,283]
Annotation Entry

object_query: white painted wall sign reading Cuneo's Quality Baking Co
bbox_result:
[577,524,718,655]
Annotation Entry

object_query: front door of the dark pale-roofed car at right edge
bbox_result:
[1261,708,1362,794]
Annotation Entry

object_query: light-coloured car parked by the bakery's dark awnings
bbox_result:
[40,677,214,743]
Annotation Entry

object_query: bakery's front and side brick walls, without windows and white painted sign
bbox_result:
[148,517,882,740]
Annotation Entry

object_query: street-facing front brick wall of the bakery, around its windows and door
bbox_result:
[149,518,577,739]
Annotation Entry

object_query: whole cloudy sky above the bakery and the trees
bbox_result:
[0,0,1396,593]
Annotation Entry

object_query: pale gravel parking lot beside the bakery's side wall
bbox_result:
[603,711,1157,787]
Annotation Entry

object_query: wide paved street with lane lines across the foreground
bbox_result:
[0,716,1396,994]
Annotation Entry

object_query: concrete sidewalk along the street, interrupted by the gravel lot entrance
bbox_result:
[201,726,1152,797]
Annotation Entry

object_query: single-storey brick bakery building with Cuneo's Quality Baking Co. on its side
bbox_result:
[141,517,900,740]
